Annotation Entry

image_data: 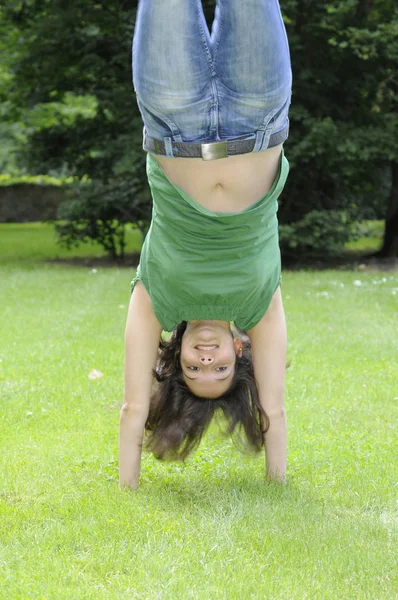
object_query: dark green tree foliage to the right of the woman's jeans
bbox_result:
[280,0,398,255]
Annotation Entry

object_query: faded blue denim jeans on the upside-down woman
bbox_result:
[133,0,292,157]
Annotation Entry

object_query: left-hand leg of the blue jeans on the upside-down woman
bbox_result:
[133,0,212,141]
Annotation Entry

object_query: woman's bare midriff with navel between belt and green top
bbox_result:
[154,145,282,212]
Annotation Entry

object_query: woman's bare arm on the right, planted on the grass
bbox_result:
[247,287,287,482]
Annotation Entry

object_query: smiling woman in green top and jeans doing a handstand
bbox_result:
[120,0,291,487]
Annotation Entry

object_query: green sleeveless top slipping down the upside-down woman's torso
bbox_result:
[130,150,289,331]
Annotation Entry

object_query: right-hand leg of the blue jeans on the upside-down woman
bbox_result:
[211,0,292,145]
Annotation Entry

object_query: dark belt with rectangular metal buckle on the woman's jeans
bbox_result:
[142,125,289,160]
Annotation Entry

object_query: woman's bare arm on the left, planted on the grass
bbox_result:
[119,282,162,488]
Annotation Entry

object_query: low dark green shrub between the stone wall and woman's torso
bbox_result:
[55,171,150,259]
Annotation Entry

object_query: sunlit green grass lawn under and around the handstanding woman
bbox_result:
[0,224,398,600]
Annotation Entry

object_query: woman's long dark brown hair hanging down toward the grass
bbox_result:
[145,321,269,460]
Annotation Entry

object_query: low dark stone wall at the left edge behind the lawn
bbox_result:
[0,183,65,223]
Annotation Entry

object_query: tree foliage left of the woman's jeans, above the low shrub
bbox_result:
[0,0,142,181]
